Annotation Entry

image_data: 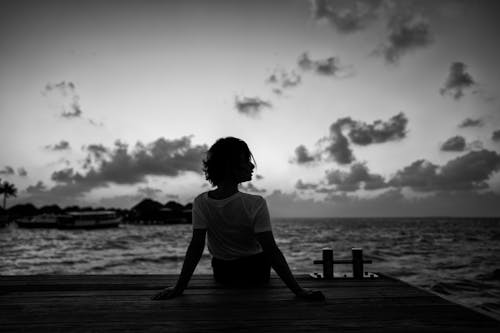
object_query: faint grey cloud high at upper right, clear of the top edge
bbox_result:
[375,13,433,64]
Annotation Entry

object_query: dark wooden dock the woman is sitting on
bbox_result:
[0,275,500,332]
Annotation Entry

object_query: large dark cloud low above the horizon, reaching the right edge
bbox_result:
[389,149,500,191]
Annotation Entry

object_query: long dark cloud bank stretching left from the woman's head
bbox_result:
[28,137,208,198]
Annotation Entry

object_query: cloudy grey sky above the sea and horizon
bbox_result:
[0,0,500,217]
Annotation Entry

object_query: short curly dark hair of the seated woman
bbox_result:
[203,137,256,186]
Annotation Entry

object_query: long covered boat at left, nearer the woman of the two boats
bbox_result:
[57,210,121,229]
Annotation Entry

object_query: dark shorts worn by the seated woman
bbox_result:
[212,252,271,286]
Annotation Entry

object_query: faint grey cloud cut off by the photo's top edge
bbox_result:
[311,0,382,33]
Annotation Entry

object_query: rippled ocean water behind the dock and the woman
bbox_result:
[0,218,500,319]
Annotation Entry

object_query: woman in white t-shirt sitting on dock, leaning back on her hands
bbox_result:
[152,137,324,300]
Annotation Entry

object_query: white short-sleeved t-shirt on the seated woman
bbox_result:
[193,192,272,260]
